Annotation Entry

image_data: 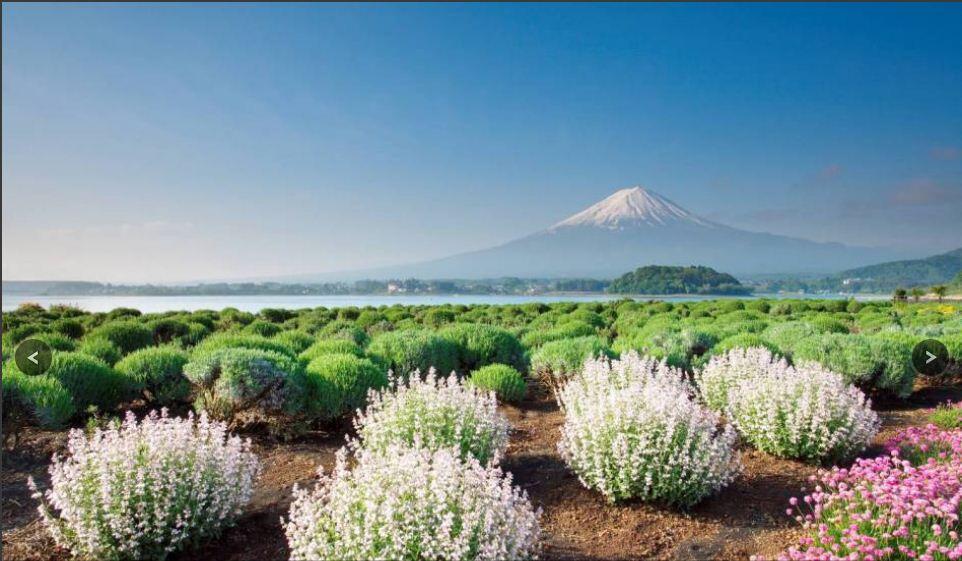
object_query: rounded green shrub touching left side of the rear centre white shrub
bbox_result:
[306,353,387,417]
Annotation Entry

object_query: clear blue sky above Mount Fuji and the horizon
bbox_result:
[3,4,962,282]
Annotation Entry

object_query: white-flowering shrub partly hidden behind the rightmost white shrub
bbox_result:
[695,347,791,412]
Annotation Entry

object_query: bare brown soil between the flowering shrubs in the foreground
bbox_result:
[0,385,962,561]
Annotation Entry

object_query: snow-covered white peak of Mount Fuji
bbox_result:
[549,187,715,231]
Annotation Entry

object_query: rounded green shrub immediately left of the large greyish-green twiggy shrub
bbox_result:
[115,346,190,405]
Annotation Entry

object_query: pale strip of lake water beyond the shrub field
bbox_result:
[0,294,887,313]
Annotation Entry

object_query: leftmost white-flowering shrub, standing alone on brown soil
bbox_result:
[30,410,259,560]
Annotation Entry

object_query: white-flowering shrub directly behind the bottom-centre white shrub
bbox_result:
[354,370,510,464]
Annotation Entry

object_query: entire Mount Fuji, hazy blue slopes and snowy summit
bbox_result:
[316,187,904,279]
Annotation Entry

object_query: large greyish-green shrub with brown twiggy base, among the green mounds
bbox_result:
[184,347,306,420]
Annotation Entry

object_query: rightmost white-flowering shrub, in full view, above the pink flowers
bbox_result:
[727,363,880,461]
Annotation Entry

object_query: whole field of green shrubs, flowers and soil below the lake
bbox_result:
[2,300,962,561]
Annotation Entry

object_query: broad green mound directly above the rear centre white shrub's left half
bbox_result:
[367,330,458,377]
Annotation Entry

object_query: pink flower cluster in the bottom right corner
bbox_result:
[764,426,962,561]
